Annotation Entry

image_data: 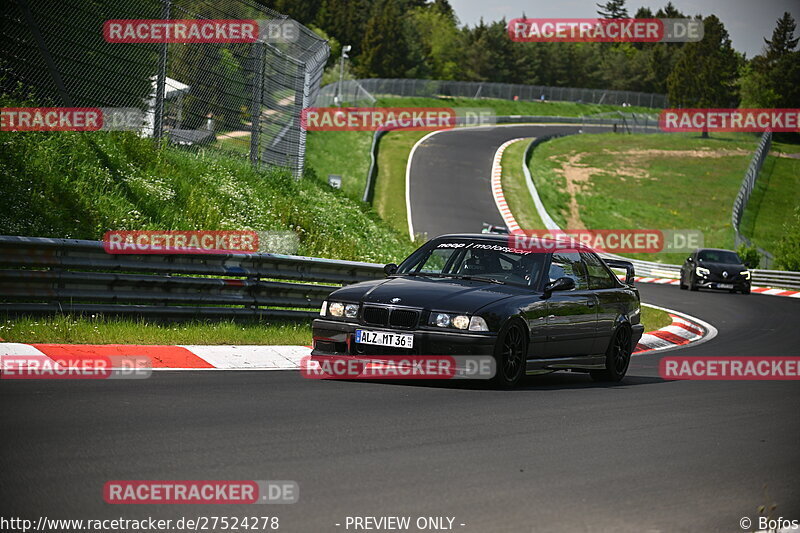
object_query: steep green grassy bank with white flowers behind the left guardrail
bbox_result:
[0,128,412,262]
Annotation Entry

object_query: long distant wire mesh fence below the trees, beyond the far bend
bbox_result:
[318,78,667,108]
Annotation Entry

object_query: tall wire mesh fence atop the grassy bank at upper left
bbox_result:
[0,0,330,175]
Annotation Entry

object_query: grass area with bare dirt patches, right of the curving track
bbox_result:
[530,133,758,263]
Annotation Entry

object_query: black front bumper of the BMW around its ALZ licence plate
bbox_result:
[311,319,497,356]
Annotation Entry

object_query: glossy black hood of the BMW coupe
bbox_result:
[328,277,532,313]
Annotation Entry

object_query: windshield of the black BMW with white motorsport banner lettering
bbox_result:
[397,240,545,287]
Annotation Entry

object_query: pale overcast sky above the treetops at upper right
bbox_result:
[450,0,800,58]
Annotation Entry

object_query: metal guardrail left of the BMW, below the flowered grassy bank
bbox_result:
[0,236,384,318]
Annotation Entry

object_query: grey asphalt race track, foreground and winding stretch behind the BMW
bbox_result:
[0,127,800,532]
